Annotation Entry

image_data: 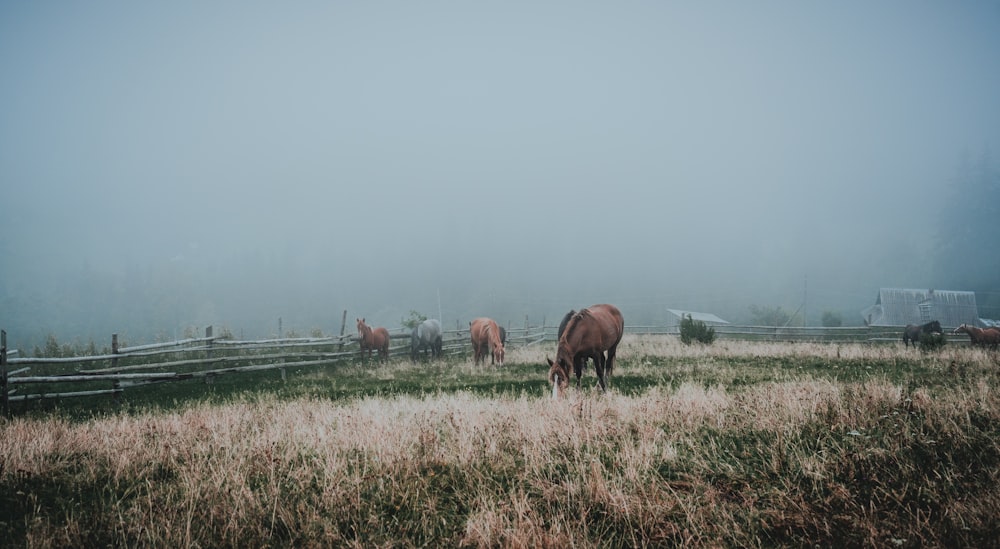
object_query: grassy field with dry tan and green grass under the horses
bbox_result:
[0,336,1000,547]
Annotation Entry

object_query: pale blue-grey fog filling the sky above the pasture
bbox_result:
[0,1,1000,341]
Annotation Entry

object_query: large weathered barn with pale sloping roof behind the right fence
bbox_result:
[861,288,982,327]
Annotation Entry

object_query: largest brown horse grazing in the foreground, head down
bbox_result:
[546,304,625,397]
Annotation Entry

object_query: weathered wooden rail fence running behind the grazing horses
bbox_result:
[0,322,968,414]
